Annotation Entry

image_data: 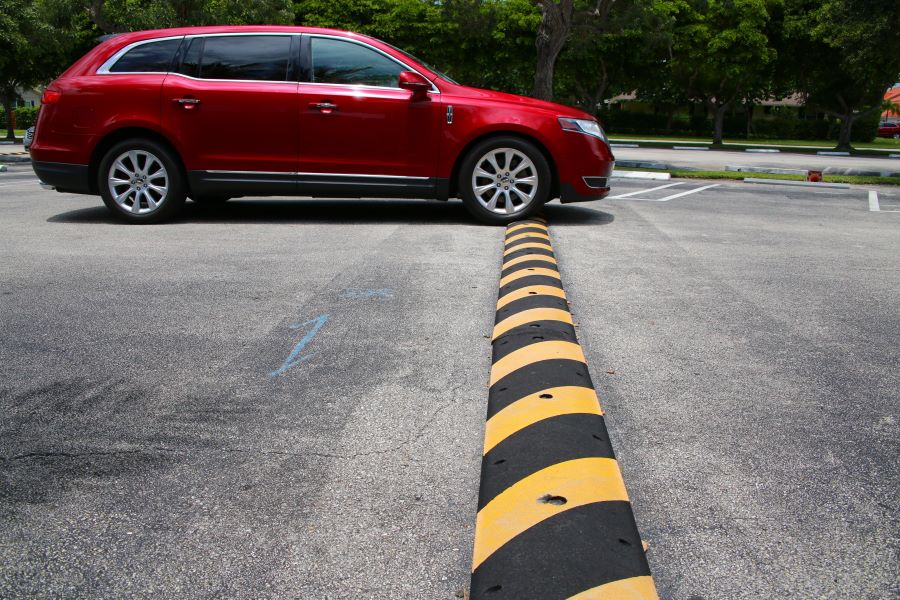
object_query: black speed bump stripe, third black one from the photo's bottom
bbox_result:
[488,359,594,419]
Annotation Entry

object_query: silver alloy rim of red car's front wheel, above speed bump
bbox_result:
[472,148,538,215]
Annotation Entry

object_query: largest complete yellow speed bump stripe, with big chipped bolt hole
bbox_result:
[472,458,628,571]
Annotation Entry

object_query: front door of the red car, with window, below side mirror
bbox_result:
[299,35,441,183]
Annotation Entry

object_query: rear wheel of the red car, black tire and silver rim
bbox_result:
[97,138,187,224]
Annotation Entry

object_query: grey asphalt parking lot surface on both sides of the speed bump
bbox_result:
[0,165,900,600]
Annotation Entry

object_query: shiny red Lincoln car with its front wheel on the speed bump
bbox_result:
[30,26,613,224]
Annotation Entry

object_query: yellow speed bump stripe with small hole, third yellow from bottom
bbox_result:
[484,385,603,454]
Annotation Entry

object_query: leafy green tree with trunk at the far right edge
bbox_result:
[784,0,900,150]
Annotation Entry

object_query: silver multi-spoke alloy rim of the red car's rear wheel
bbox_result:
[107,150,169,215]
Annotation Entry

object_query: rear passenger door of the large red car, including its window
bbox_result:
[162,33,299,178]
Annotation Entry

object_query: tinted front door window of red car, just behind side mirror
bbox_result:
[311,38,404,87]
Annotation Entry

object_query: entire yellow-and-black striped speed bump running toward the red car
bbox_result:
[471,219,659,600]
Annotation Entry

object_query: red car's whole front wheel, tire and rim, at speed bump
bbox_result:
[458,137,551,225]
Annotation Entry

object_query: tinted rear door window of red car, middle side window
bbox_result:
[199,35,291,81]
